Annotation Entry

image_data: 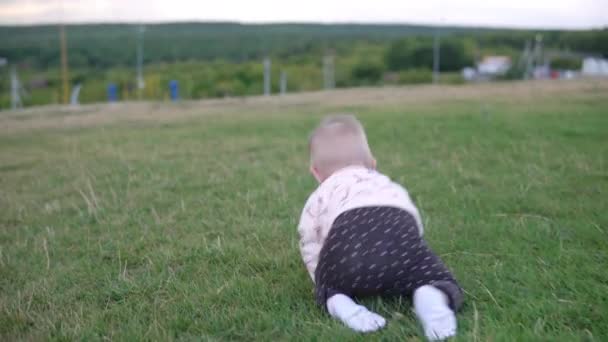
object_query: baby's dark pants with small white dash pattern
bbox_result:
[315,207,463,311]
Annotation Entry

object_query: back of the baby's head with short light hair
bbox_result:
[308,115,376,183]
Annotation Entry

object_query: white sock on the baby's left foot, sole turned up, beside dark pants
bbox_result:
[327,294,386,333]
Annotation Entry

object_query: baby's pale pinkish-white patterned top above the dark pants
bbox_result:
[298,166,423,281]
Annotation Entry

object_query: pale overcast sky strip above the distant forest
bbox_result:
[0,0,608,28]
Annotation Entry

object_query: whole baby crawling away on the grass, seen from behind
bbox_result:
[298,115,463,340]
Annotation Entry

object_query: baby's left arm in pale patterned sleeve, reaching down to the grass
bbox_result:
[298,194,322,282]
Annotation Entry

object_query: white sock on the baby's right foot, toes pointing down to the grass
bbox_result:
[414,285,456,341]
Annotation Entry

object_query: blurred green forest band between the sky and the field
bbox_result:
[0,23,608,108]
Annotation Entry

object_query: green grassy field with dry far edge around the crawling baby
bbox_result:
[0,80,608,341]
